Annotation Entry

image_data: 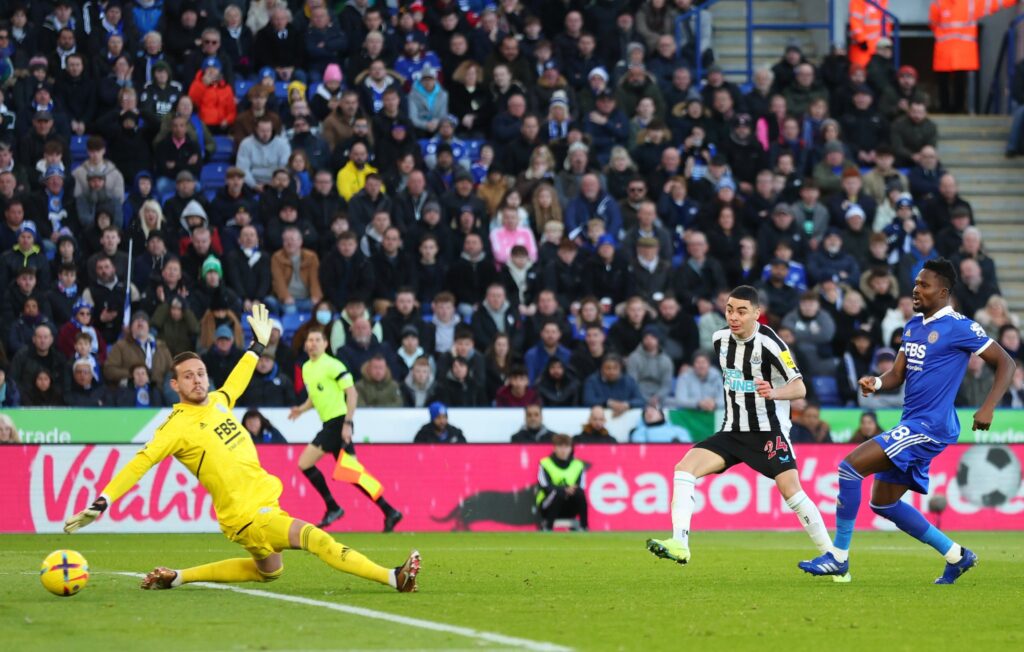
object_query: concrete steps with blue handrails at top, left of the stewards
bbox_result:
[711,0,819,82]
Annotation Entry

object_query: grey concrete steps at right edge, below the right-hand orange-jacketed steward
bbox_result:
[932,116,1024,313]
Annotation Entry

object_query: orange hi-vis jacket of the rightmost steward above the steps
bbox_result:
[928,0,1017,73]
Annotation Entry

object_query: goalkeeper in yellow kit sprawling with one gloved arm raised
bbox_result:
[65,304,420,593]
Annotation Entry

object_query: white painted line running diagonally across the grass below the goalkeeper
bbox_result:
[113,571,572,652]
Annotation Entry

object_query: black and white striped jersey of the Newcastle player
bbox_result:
[713,323,801,436]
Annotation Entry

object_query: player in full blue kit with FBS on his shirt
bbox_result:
[799,259,1014,584]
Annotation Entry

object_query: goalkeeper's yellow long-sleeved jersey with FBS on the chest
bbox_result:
[102,352,283,533]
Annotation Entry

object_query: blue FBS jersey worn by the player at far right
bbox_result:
[900,306,992,444]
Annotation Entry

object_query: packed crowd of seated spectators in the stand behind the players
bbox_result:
[0,0,1024,415]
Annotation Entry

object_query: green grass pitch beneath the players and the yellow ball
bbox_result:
[0,532,1024,652]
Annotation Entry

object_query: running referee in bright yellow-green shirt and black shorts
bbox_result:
[288,329,401,532]
